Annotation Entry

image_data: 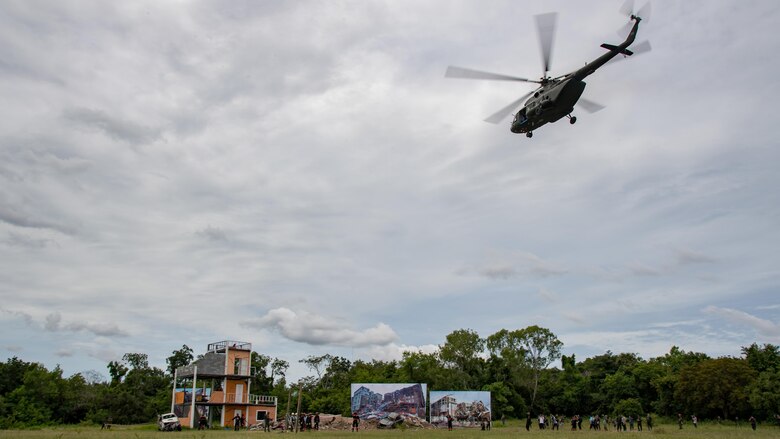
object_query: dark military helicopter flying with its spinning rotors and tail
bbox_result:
[444,0,651,138]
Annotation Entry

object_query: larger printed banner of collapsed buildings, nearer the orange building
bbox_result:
[351,383,428,419]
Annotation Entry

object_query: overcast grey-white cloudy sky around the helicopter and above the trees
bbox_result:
[0,0,780,382]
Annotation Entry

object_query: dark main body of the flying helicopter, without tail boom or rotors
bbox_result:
[511,77,585,133]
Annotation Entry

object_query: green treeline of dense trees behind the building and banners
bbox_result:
[0,326,780,429]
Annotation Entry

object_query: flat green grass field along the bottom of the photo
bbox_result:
[0,422,780,439]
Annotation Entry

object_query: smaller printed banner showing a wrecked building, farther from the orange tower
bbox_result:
[430,390,491,427]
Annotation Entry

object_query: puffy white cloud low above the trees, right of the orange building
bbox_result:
[241,308,398,347]
